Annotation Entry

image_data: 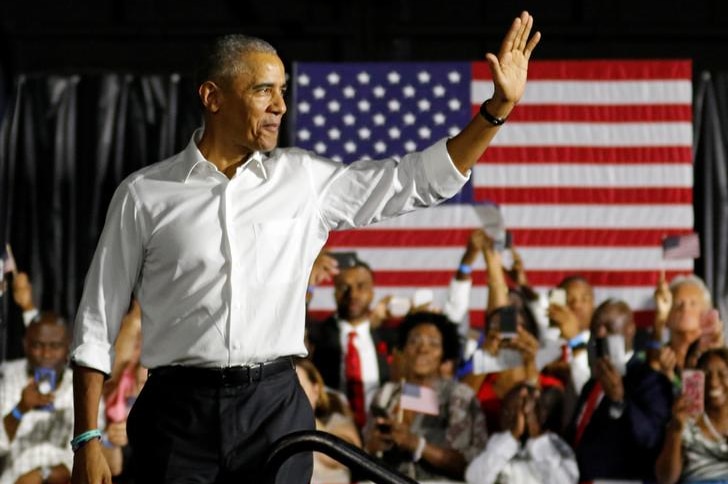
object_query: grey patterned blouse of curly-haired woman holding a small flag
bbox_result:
[367,379,487,481]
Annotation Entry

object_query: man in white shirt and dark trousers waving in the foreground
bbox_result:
[72,12,540,484]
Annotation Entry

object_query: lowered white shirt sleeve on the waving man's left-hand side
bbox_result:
[71,181,145,374]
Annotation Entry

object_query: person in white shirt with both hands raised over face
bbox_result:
[465,383,579,484]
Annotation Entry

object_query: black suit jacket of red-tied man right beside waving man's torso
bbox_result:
[308,315,391,389]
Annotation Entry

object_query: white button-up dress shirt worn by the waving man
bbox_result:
[72,130,467,373]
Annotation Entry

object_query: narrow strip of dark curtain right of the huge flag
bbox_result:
[694,72,728,328]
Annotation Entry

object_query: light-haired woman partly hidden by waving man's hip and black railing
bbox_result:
[296,358,361,484]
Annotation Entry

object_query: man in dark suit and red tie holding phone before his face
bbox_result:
[566,300,672,482]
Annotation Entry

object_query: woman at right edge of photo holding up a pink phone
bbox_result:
[656,348,728,484]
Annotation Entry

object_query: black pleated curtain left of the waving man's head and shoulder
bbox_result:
[0,74,201,358]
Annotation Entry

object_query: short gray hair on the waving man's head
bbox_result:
[196,34,277,86]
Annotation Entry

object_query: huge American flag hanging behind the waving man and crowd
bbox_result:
[291,60,693,326]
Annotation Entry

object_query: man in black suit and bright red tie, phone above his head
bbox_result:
[308,259,394,429]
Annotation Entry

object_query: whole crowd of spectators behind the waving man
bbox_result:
[0,229,728,484]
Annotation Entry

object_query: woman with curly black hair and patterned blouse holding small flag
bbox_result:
[364,312,486,480]
